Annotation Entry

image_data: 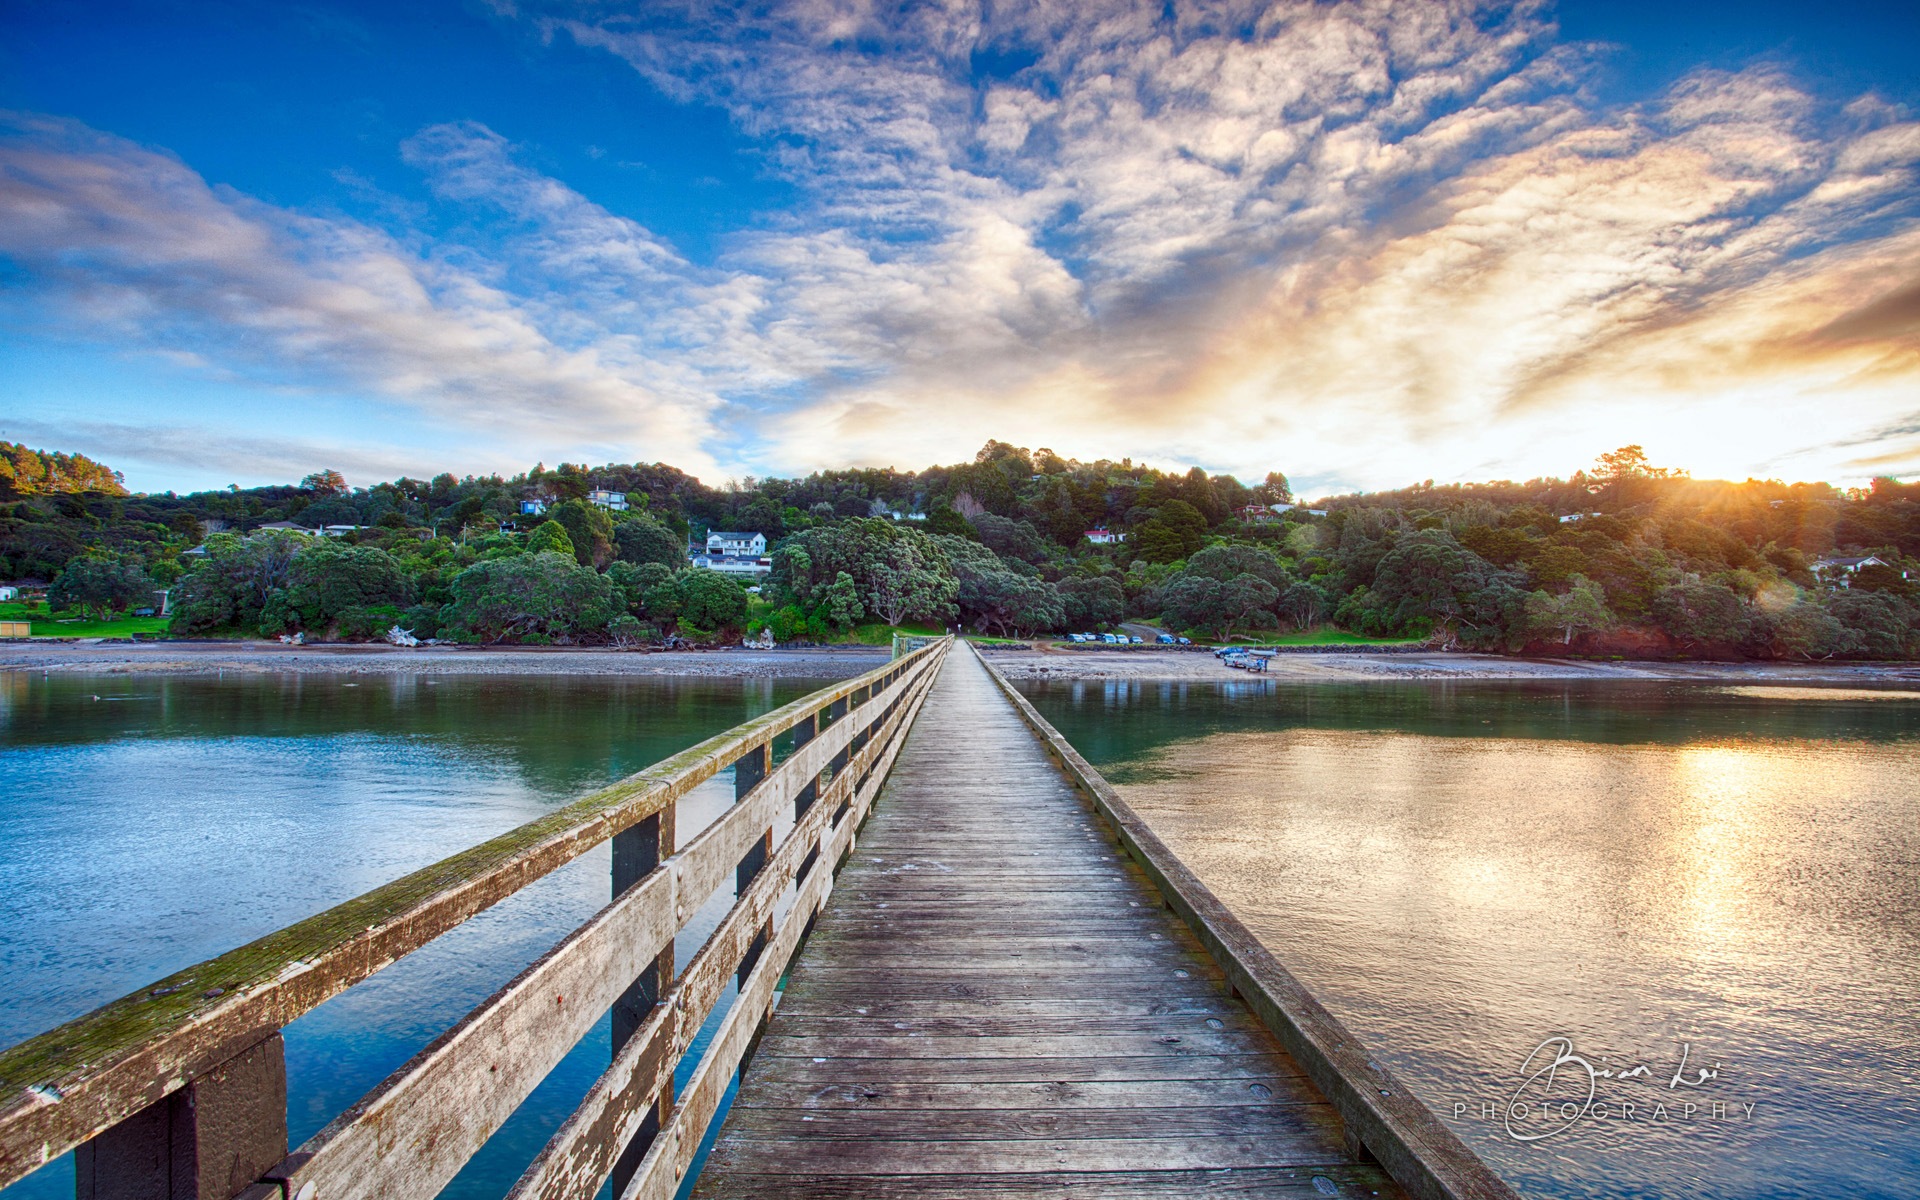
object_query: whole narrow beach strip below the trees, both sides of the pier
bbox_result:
[0,639,1920,684]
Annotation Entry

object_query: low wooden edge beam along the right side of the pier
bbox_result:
[968,647,1519,1200]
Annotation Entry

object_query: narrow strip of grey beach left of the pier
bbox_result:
[0,641,889,680]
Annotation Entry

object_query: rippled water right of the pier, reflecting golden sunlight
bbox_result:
[1027,680,1920,1200]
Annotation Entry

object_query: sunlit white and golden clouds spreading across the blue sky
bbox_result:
[0,0,1920,486]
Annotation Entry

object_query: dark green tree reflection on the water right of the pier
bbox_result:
[1021,680,1920,764]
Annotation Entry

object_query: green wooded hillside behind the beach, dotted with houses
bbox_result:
[0,442,1920,659]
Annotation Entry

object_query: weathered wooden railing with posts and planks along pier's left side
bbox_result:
[0,639,948,1200]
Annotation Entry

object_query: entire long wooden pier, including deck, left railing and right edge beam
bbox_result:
[0,639,1513,1200]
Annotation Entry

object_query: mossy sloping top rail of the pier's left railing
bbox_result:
[0,647,945,1187]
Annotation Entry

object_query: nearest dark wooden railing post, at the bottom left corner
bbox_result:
[73,1033,286,1200]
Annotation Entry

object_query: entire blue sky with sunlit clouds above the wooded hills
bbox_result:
[0,0,1920,490]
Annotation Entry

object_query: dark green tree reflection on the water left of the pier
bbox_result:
[0,674,828,795]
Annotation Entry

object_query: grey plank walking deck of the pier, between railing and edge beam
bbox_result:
[695,649,1400,1200]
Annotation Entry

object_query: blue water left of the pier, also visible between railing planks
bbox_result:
[0,664,866,1200]
